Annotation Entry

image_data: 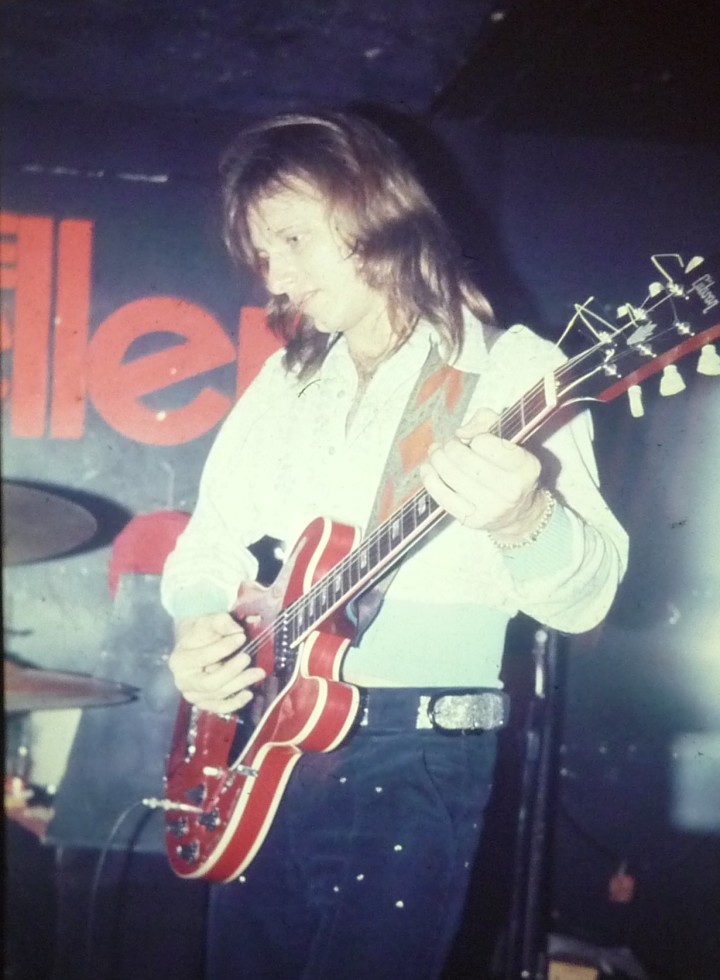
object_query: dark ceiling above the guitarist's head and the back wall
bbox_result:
[0,0,720,145]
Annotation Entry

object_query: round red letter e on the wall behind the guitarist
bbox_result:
[88,296,235,446]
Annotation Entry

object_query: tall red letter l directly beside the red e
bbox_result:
[50,220,93,439]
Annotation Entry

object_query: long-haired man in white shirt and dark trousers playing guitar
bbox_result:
[163,113,626,980]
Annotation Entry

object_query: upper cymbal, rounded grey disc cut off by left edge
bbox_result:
[2,480,97,565]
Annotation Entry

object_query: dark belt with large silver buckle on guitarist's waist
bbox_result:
[359,687,510,735]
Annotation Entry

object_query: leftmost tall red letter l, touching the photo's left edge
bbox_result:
[0,213,53,438]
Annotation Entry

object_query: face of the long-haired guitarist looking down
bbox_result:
[248,182,388,344]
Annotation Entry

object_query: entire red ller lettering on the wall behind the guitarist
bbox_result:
[0,212,280,445]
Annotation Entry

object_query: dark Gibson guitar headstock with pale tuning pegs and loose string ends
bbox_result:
[558,256,720,415]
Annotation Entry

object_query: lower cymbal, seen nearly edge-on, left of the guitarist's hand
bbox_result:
[4,660,137,714]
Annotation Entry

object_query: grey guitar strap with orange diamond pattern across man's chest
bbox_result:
[348,325,501,642]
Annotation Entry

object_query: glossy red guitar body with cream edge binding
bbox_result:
[165,518,359,881]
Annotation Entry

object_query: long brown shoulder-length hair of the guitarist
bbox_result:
[221,112,494,376]
